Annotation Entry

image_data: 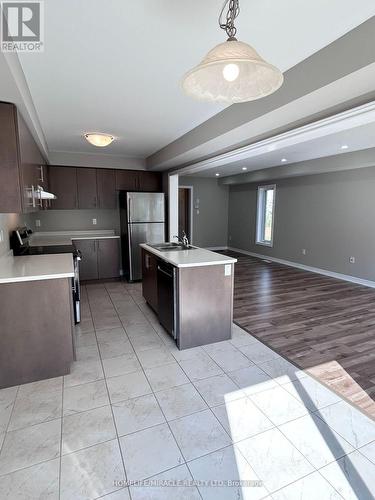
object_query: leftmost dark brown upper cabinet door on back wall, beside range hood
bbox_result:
[49,166,78,210]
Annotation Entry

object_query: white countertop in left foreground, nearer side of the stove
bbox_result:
[0,253,74,283]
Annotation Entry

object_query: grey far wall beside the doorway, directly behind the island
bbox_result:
[179,177,229,247]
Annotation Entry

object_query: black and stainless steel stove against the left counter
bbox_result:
[10,227,82,323]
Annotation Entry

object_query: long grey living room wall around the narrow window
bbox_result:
[228,167,375,280]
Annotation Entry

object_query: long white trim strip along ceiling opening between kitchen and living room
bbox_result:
[176,101,375,175]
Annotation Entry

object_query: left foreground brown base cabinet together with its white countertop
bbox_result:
[0,254,74,389]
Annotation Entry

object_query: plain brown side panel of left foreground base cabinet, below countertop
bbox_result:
[0,278,74,389]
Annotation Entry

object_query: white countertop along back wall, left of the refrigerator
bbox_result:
[29,230,120,247]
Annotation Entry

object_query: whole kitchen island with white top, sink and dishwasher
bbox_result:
[140,244,237,349]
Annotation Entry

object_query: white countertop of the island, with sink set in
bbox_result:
[140,243,237,267]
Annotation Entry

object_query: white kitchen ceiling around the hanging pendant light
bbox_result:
[20,0,375,160]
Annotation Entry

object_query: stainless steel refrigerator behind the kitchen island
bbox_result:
[120,191,165,281]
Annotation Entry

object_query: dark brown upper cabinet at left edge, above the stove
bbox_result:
[0,102,45,213]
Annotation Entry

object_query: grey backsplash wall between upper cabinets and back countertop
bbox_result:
[30,209,120,231]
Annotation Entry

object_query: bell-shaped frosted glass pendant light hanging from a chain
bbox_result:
[182,0,284,104]
